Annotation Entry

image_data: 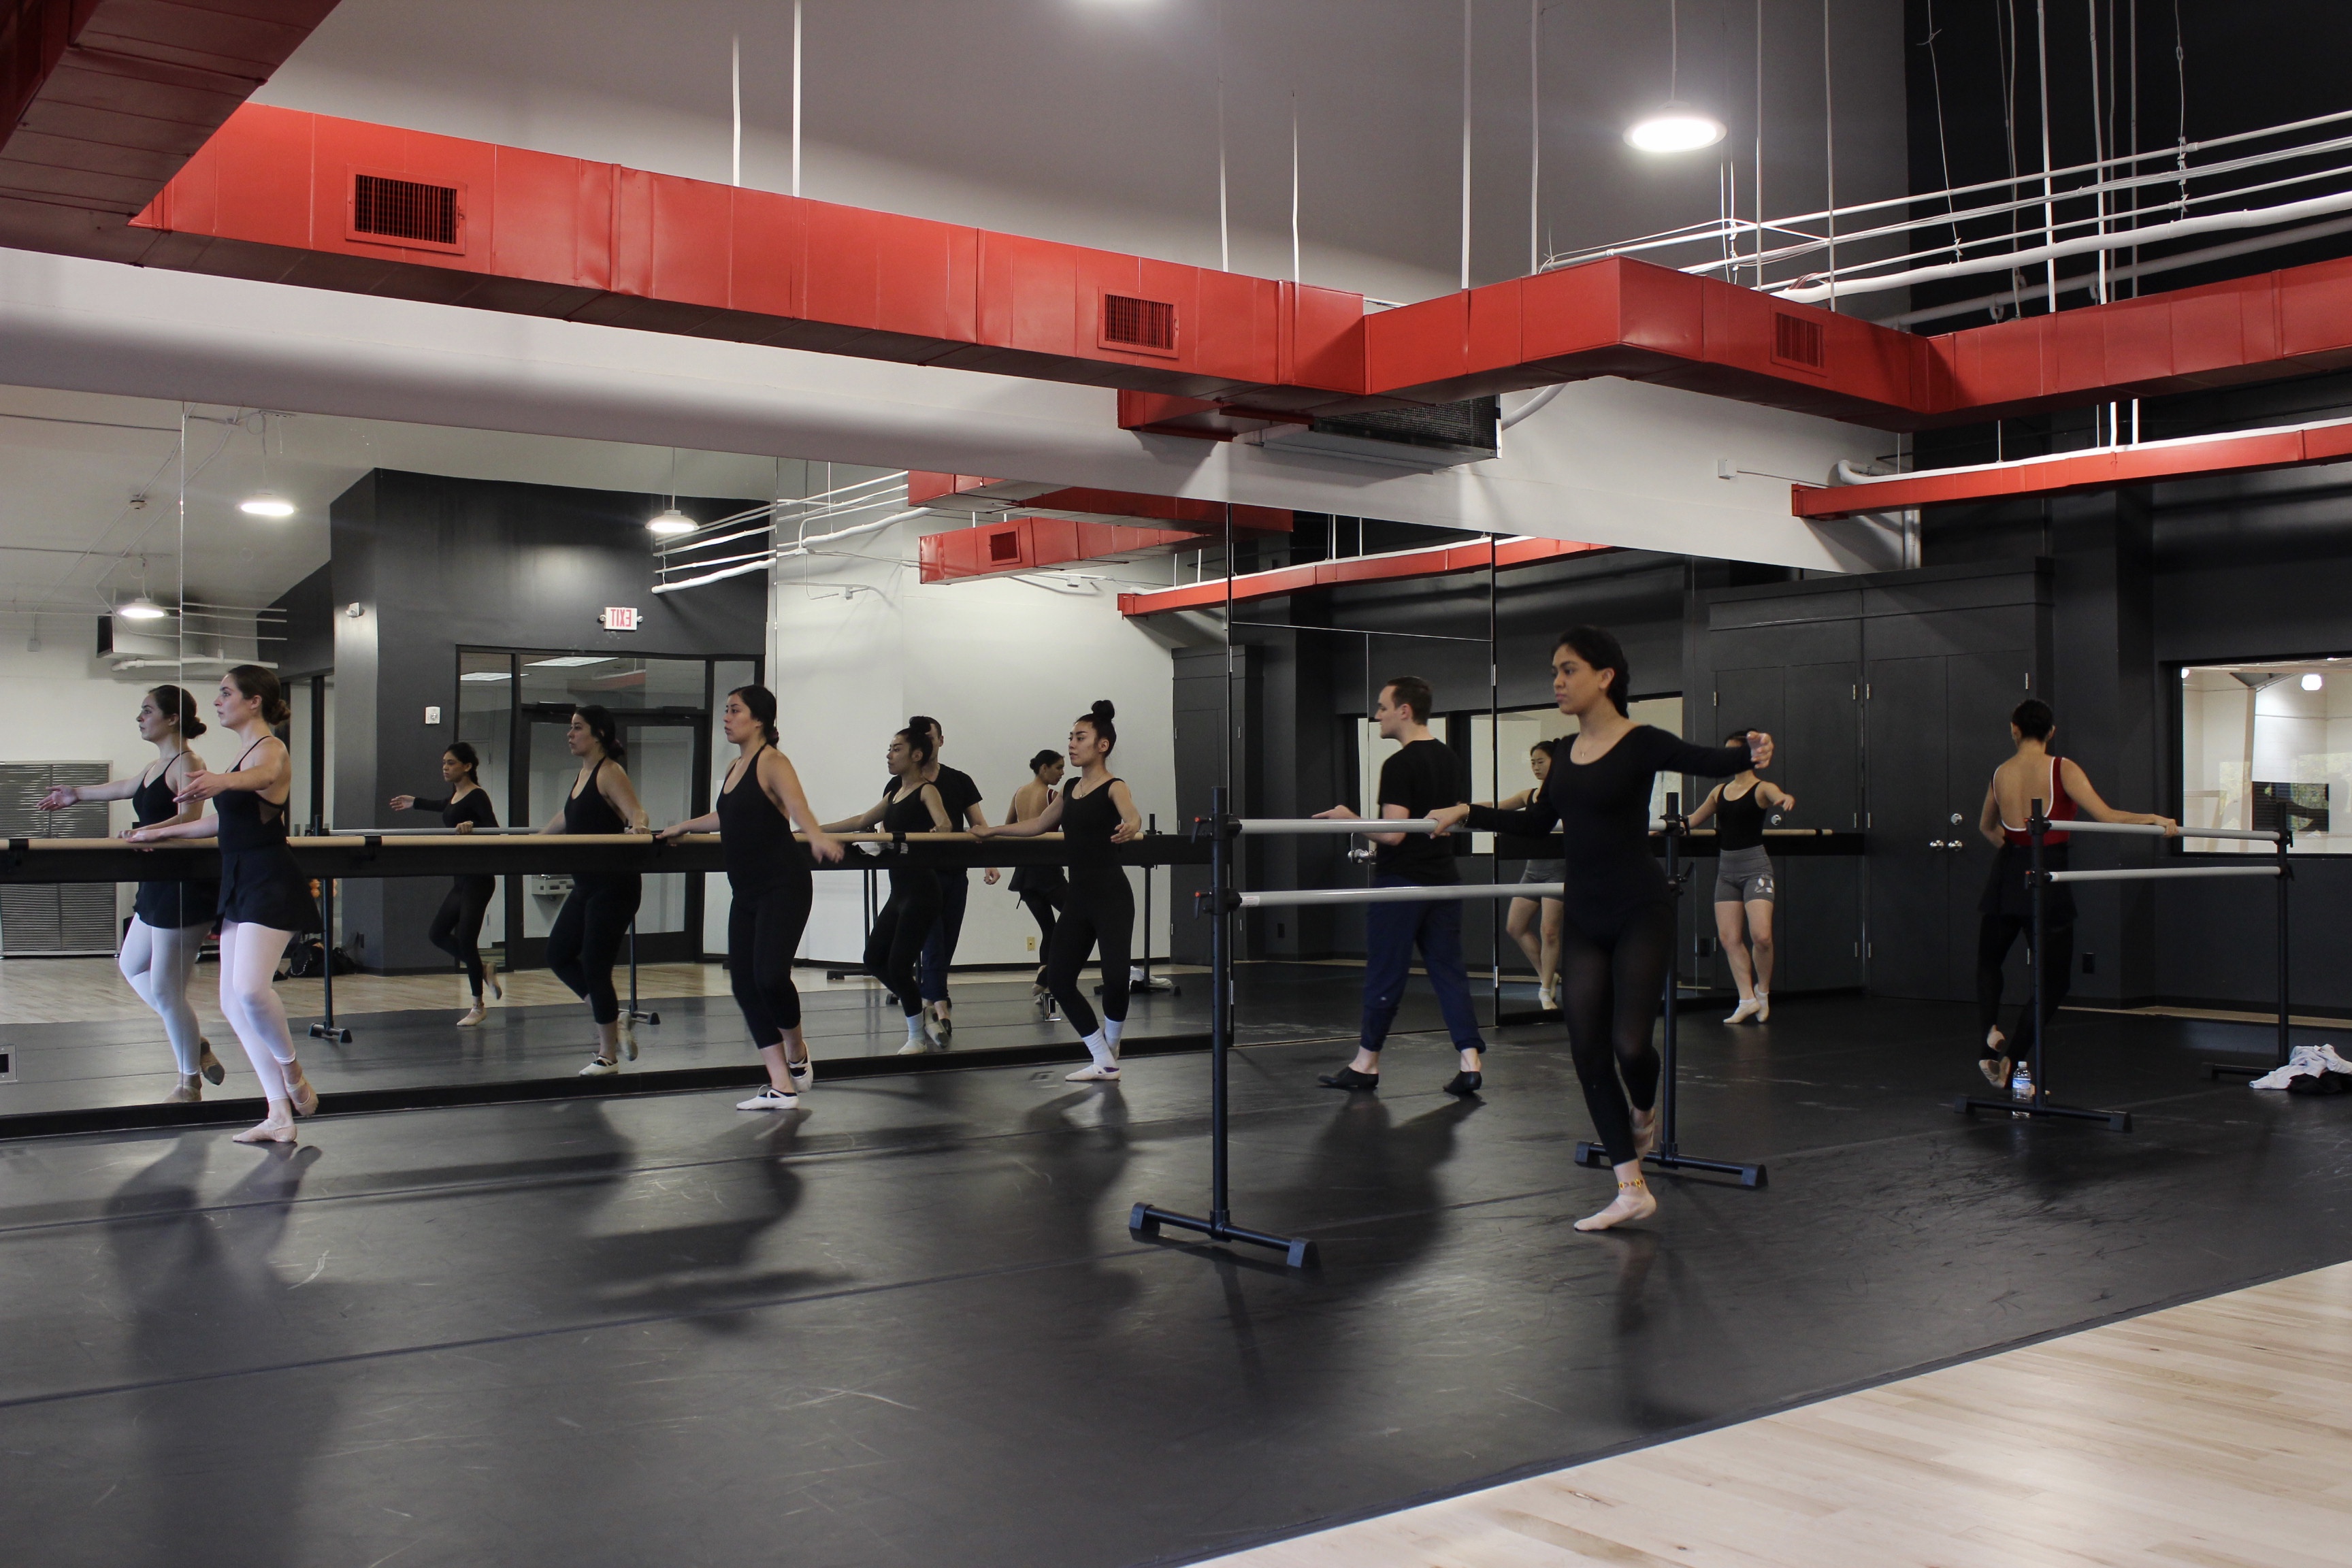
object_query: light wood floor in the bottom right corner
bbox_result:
[1216,1264,2352,1568]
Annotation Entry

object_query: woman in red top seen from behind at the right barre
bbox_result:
[1976,698,2180,1088]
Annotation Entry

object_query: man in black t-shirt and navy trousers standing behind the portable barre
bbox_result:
[1317,674,1486,1093]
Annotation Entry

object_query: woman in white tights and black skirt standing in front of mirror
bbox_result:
[122,666,320,1143]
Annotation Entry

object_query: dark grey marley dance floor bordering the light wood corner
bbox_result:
[0,999,2352,1568]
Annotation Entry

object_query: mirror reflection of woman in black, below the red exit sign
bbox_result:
[538,703,644,1079]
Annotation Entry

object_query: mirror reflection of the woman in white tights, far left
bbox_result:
[40,687,228,1105]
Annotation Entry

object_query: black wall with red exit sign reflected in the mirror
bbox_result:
[329,470,767,973]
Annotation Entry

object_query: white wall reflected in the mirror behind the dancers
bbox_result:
[769,524,1176,964]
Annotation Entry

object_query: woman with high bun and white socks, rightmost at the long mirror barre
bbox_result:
[979,703,1143,1083]
